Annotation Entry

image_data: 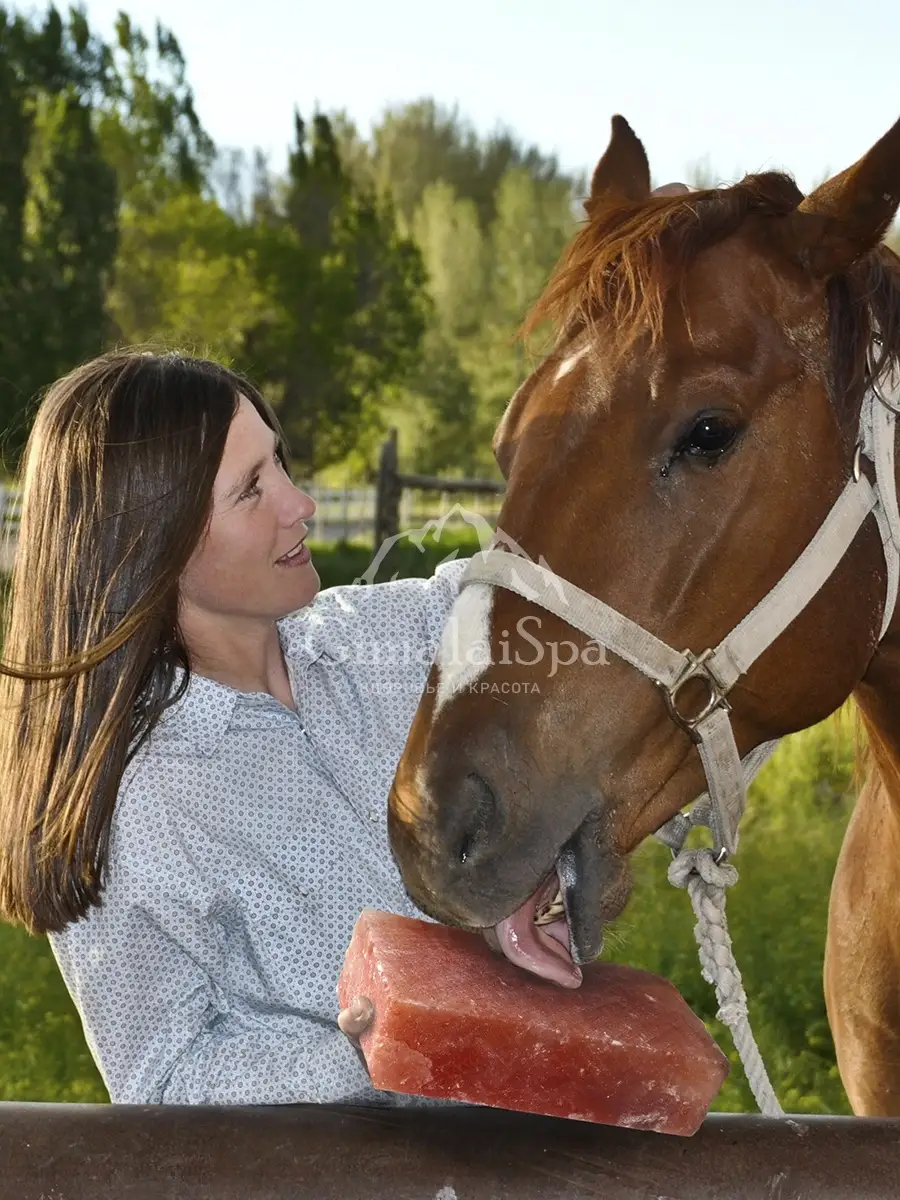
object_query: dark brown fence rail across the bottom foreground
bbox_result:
[0,1104,900,1200]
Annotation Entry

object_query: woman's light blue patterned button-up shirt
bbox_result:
[50,559,468,1104]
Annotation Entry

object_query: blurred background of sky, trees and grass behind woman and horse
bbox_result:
[0,0,899,1112]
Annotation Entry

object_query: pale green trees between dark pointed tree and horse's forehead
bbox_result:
[352,102,582,476]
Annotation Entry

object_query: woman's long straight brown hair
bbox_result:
[0,350,284,932]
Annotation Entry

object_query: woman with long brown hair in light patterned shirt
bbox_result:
[0,352,464,1104]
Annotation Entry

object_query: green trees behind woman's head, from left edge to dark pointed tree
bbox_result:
[0,8,431,475]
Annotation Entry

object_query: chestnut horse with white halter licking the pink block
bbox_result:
[388,116,900,1116]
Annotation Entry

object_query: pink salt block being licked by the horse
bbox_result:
[337,908,728,1135]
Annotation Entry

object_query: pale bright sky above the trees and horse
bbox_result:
[84,0,900,191]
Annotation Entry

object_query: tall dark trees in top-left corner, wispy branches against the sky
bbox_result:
[0,7,217,462]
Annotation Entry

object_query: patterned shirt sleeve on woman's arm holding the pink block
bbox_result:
[50,777,397,1104]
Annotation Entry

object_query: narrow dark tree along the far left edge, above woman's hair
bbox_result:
[0,8,116,461]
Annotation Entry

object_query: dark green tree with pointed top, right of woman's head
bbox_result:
[245,114,428,473]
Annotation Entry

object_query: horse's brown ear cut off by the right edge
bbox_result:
[784,121,900,278]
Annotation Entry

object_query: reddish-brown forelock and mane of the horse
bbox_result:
[522,172,900,427]
